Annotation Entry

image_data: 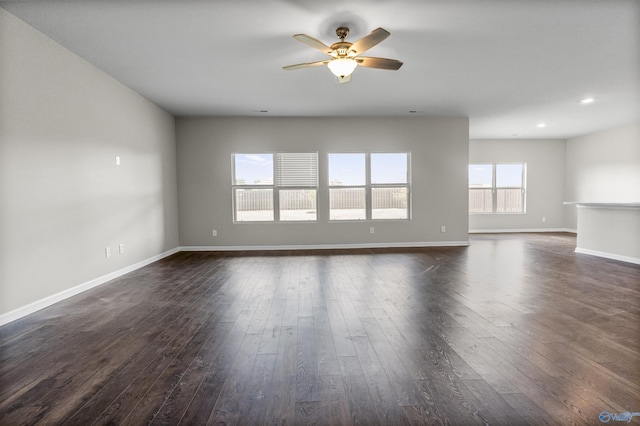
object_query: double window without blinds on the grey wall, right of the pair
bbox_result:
[329,152,410,221]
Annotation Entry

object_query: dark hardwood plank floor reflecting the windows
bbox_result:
[0,234,640,425]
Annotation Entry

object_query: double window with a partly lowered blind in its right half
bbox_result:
[233,153,318,222]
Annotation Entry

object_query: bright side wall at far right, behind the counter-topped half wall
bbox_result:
[565,122,640,228]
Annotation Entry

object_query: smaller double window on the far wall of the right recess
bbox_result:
[469,163,527,213]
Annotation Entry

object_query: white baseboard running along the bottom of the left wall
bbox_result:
[0,248,180,326]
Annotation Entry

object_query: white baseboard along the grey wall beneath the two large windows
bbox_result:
[180,241,469,251]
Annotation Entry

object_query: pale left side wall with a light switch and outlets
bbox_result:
[0,8,178,318]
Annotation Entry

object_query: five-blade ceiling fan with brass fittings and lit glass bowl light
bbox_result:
[282,27,402,83]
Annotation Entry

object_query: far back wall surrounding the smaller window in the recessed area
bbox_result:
[469,139,566,231]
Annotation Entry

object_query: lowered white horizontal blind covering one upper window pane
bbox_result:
[276,152,318,188]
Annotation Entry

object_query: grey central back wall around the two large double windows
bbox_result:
[176,117,469,247]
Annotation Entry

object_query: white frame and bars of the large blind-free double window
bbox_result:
[326,151,412,223]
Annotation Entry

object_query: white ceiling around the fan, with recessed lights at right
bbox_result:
[0,0,640,138]
